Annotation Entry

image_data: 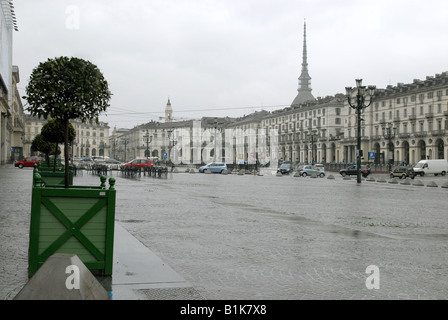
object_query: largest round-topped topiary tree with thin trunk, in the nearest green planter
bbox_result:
[23,57,111,188]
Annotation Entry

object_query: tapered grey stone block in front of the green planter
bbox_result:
[14,254,110,300]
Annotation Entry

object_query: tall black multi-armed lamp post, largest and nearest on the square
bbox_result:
[345,79,376,183]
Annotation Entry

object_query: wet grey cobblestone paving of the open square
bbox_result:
[0,166,448,300]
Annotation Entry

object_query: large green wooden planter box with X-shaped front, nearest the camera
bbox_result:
[28,172,116,278]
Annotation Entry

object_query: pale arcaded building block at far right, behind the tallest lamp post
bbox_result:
[341,72,448,164]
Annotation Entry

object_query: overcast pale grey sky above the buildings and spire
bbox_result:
[13,0,448,128]
